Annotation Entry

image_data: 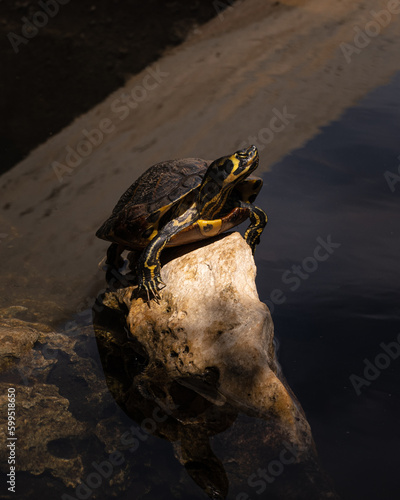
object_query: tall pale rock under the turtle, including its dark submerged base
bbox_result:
[96,233,336,499]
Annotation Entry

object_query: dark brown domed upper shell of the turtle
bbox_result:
[96,158,211,248]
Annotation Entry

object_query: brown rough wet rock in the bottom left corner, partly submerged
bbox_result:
[0,307,132,499]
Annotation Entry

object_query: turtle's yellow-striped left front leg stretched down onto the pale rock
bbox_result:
[132,207,198,301]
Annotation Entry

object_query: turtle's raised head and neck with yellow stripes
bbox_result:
[198,146,259,218]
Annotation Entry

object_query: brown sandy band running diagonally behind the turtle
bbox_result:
[0,0,400,317]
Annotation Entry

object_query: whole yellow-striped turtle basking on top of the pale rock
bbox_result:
[96,146,267,300]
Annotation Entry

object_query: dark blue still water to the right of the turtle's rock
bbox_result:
[252,70,400,500]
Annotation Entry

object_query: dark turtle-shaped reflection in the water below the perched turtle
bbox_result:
[94,296,231,498]
